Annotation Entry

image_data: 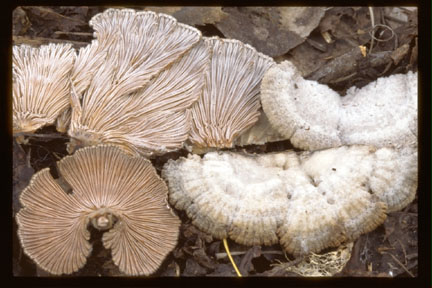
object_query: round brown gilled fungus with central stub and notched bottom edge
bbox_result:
[17,145,180,275]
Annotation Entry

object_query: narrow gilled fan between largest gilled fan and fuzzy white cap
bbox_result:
[190,37,274,149]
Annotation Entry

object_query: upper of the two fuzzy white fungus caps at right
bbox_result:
[261,61,417,150]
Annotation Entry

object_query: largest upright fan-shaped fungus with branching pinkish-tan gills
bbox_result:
[68,9,209,156]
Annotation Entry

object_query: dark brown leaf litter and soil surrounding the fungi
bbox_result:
[13,6,418,277]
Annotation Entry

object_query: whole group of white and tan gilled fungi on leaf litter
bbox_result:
[13,9,417,275]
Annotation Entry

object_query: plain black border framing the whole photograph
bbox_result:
[0,0,432,287]
